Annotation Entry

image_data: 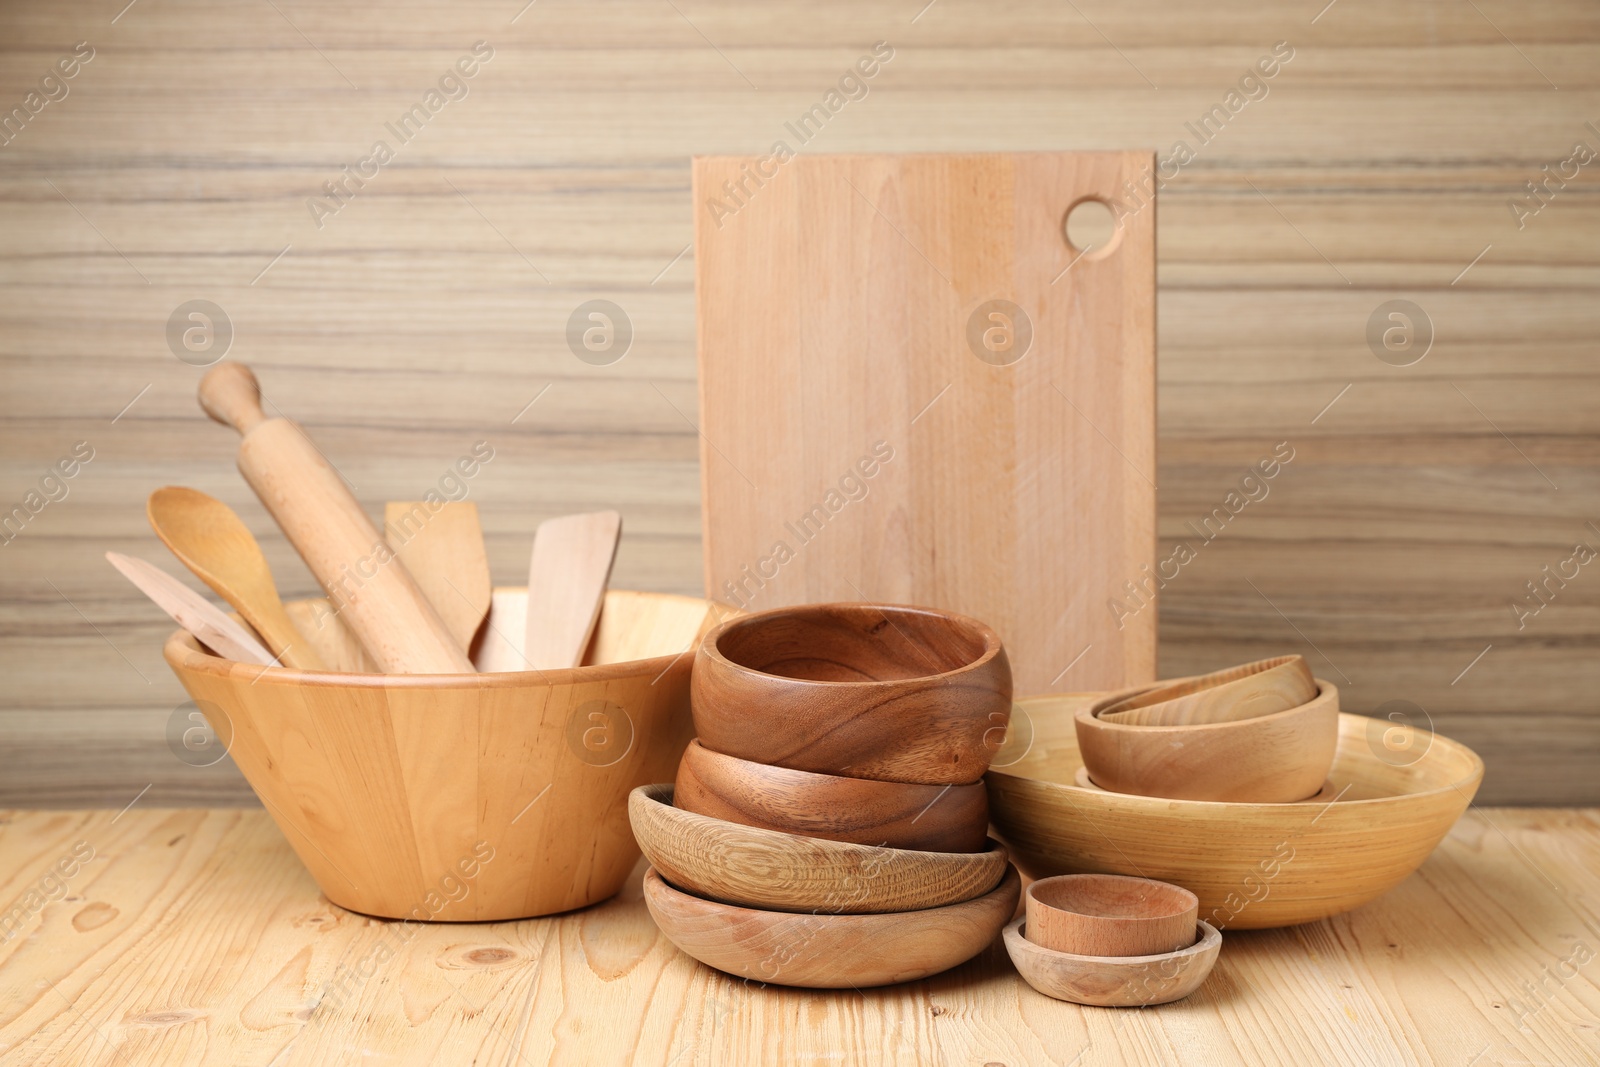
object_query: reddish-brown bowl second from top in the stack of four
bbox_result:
[672,741,989,853]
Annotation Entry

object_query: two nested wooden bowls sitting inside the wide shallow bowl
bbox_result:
[1077,656,1339,803]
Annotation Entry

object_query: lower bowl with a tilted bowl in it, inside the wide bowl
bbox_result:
[1077,680,1339,803]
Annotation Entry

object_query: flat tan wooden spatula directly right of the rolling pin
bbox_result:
[384,501,491,653]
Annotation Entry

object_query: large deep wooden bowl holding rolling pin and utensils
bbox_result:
[165,590,726,921]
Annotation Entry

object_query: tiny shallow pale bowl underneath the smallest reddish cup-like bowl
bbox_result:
[1005,918,1222,1008]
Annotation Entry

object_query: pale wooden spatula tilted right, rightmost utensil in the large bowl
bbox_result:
[523,512,622,670]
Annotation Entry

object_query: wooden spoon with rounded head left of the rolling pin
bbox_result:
[144,485,326,670]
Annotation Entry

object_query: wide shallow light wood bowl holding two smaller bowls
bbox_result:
[986,694,1483,929]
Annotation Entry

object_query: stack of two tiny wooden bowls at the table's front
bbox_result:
[1005,875,1222,1008]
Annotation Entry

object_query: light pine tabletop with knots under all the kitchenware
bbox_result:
[0,806,1600,1067]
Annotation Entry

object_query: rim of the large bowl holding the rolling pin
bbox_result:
[162,585,718,689]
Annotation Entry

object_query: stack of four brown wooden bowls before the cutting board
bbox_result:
[629,605,1021,989]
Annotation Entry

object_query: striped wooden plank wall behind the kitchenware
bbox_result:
[0,0,1600,806]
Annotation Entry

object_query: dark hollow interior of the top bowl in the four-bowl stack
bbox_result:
[717,605,987,681]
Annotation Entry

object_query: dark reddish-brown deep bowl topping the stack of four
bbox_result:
[691,603,1011,785]
